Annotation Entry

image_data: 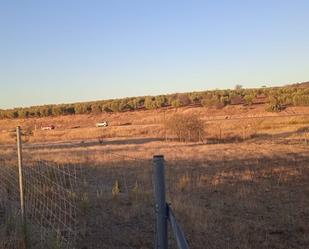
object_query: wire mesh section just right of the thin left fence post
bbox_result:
[23,160,80,249]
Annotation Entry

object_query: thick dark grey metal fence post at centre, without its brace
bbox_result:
[153,155,168,249]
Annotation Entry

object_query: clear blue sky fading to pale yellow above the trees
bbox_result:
[0,0,309,109]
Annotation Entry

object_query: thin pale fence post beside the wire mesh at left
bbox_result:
[16,126,25,223]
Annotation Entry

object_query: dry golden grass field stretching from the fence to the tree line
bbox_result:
[0,106,309,249]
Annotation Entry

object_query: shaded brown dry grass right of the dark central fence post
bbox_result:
[167,153,309,249]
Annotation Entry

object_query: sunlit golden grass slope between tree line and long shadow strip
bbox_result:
[0,106,309,144]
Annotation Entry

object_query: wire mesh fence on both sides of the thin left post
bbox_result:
[0,147,80,249]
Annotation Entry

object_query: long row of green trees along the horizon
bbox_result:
[0,86,309,119]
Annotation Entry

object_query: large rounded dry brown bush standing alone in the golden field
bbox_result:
[165,114,205,142]
